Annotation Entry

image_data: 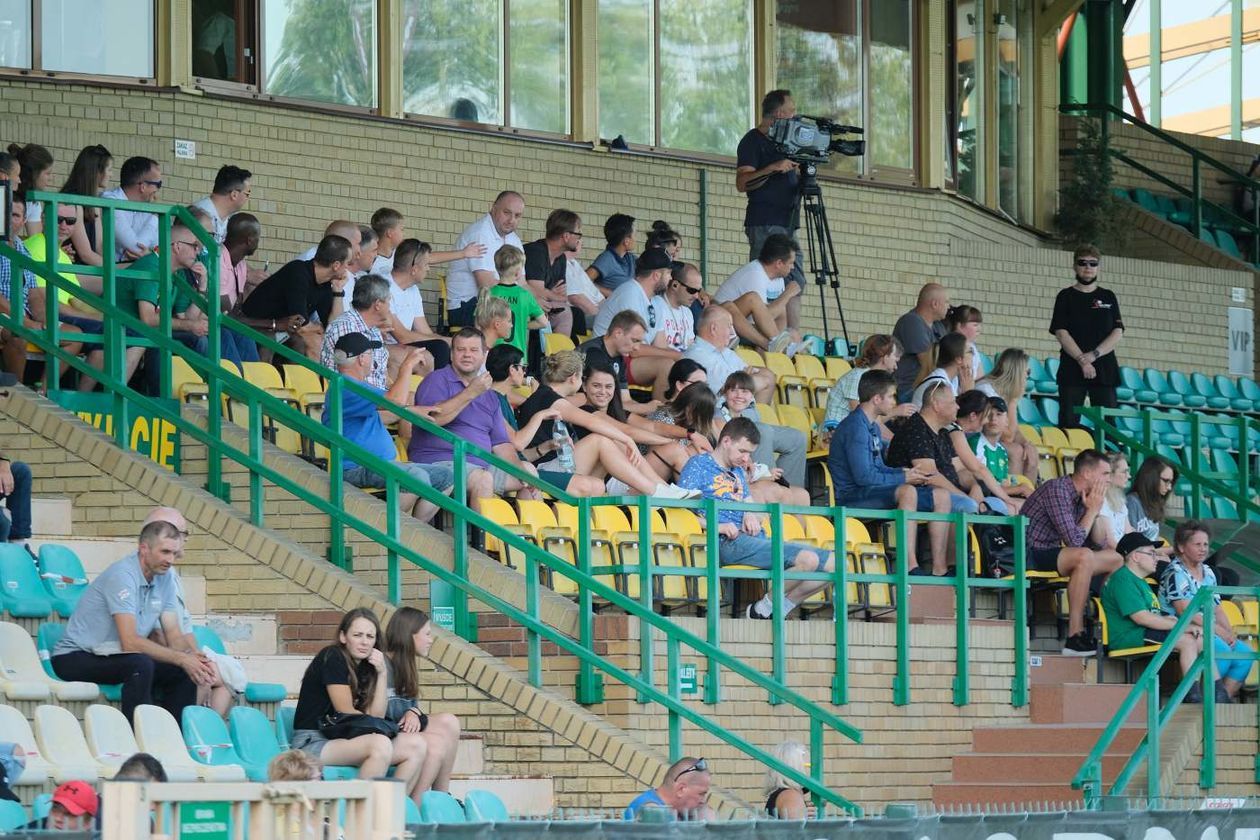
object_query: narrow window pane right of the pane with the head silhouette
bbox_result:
[508,0,570,133]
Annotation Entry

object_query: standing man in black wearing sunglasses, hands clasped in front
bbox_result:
[1050,246,1124,428]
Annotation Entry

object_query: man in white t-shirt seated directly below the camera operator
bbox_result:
[713,233,800,356]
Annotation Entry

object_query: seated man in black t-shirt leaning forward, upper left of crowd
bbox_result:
[239,234,350,361]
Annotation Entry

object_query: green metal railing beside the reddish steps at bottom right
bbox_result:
[1072,587,1260,807]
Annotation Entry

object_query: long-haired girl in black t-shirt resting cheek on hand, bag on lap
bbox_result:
[291,607,427,805]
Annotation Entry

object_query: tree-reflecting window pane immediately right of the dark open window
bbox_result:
[263,0,377,108]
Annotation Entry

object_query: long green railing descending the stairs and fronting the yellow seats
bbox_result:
[0,193,1027,812]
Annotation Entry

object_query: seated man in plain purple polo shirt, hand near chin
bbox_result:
[407,327,537,513]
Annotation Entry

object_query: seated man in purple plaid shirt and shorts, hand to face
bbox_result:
[1021,450,1124,656]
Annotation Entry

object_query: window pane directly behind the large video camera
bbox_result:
[775,0,862,175]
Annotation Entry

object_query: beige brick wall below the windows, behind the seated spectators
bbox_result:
[0,79,1252,373]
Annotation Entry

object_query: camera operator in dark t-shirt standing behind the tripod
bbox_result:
[735,91,805,330]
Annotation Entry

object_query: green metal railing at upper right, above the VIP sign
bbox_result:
[1058,102,1260,257]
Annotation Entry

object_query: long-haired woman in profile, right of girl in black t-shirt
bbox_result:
[384,607,460,791]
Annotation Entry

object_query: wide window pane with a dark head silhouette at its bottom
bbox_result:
[402,0,503,125]
